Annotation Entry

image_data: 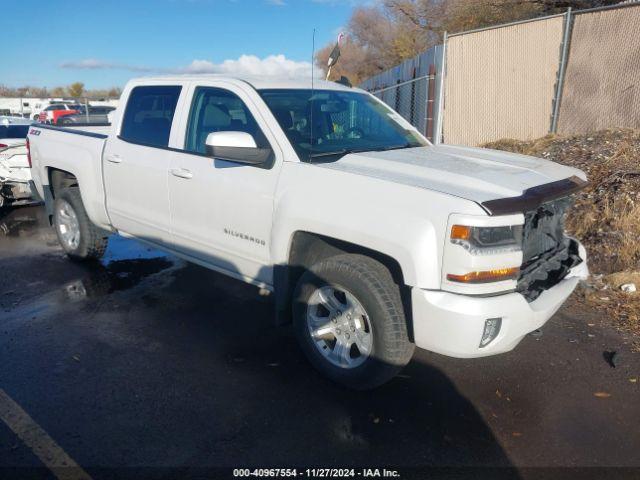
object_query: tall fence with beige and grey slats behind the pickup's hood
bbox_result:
[361,1,640,145]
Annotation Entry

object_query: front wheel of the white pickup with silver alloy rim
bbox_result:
[293,254,415,390]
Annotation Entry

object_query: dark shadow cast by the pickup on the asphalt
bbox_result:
[94,265,520,479]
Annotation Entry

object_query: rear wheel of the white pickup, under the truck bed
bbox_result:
[53,187,108,260]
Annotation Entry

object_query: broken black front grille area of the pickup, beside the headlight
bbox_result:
[516,197,582,302]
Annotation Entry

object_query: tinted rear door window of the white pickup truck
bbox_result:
[120,86,182,147]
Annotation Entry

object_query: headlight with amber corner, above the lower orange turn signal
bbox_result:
[451,225,522,255]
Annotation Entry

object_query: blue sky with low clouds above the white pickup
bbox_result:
[0,0,370,88]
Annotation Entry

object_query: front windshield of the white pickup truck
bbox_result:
[259,89,429,162]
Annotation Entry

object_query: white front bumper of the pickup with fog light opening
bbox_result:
[411,240,589,358]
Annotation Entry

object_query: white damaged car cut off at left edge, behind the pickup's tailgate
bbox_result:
[0,117,33,207]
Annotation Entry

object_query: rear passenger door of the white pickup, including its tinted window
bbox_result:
[103,85,183,246]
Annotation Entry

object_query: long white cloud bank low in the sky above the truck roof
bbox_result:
[60,54,317,78]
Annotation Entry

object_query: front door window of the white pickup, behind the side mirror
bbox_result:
[184,87,267,153]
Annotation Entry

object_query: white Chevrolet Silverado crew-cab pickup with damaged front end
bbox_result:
[29,75,588,389]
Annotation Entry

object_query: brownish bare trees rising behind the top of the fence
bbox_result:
[316,0,623,83]
